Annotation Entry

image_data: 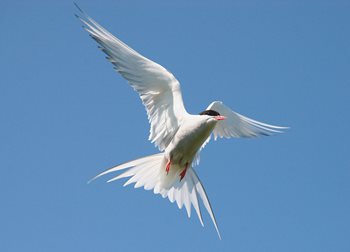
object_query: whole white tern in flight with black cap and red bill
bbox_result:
[77,6,285,239]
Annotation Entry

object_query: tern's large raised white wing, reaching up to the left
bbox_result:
[77,7,187,151]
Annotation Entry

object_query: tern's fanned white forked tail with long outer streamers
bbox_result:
[89,153,221,239]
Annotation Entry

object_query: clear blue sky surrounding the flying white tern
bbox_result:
[0,0,350,252]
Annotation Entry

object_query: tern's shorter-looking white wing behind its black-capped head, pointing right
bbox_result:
[207,101,287,140]
